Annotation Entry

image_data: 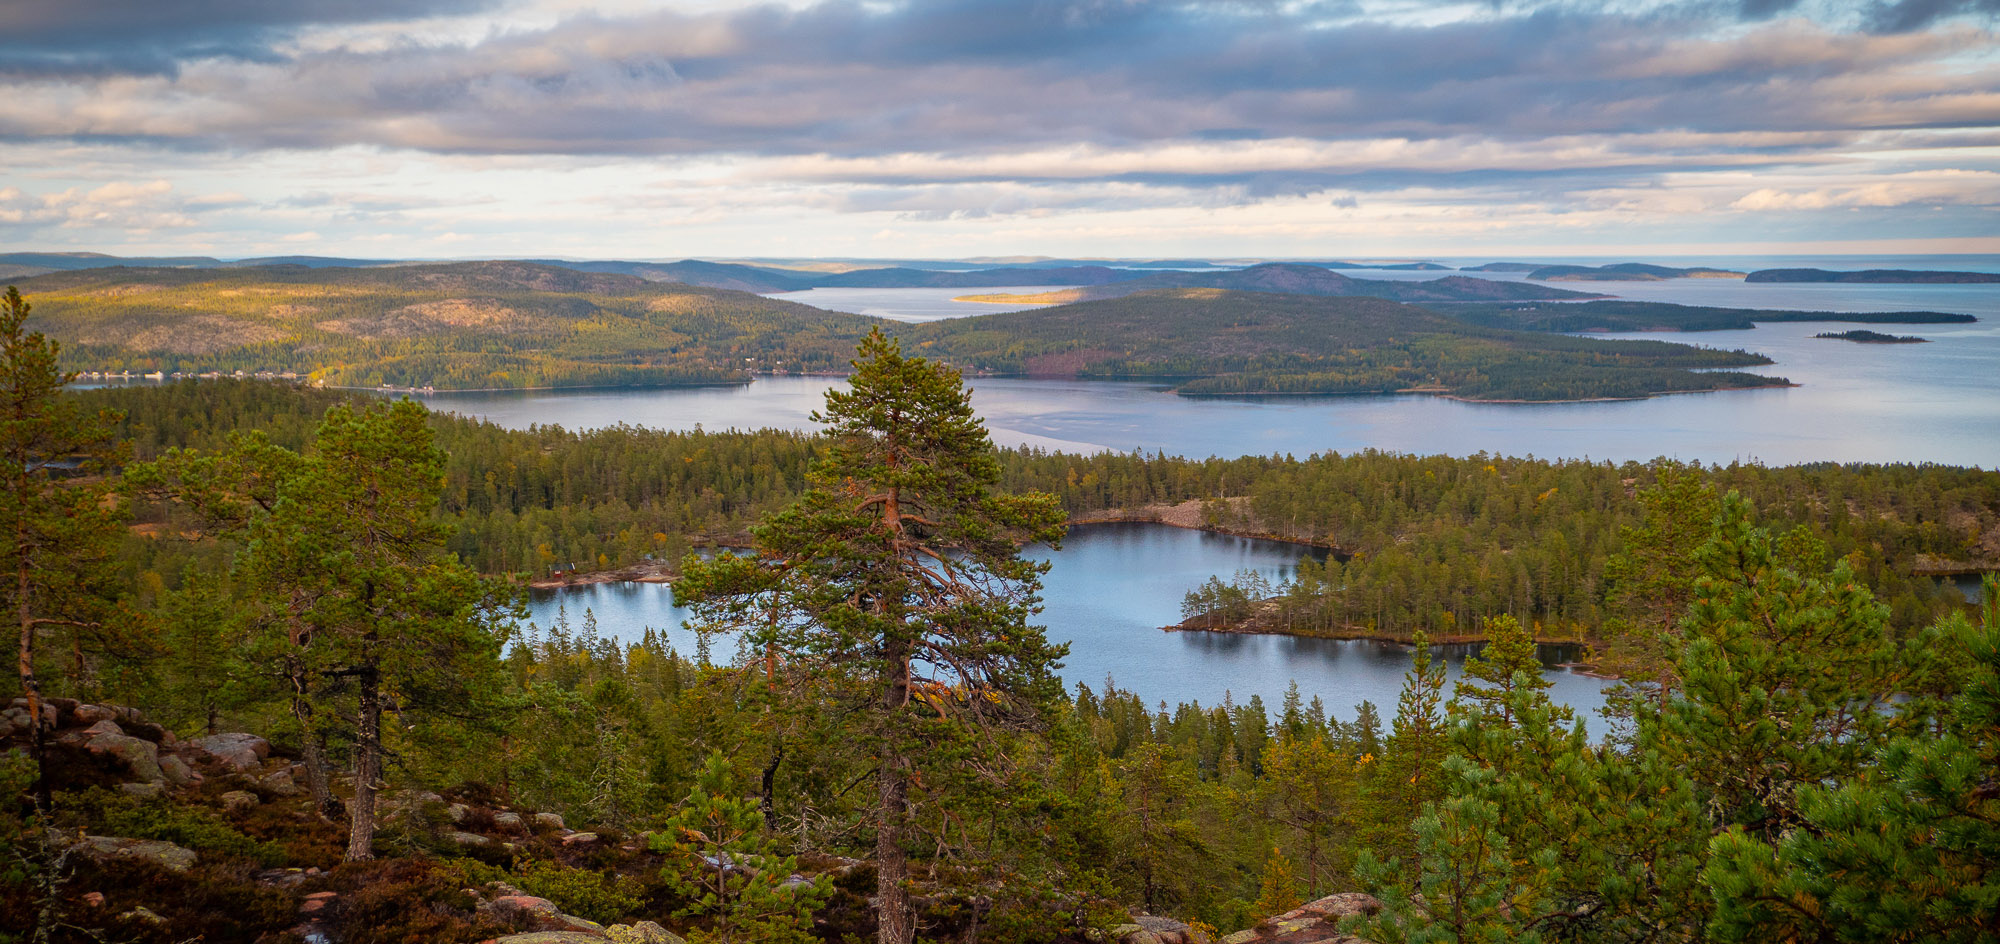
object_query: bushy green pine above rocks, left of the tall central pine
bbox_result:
[246,400,514,860]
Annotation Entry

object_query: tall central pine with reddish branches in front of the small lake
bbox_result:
[674,330,1064,944]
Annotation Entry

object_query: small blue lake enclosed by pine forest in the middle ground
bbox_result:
[530,524,1604,718]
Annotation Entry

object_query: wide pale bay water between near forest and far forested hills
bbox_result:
[428,310,2000,468]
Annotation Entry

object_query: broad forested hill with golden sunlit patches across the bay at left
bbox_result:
[20,262,876,388]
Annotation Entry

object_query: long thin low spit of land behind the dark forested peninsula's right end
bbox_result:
[1436,300,1978,332]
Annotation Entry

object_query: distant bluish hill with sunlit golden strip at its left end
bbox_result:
[948,262,1604,304]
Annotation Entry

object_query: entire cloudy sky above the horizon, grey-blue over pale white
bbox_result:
[0,0,2000,258]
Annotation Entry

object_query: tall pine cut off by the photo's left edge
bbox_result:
[0,286,124,802]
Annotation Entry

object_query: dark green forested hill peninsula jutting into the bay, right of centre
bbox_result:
[902,288,1786,400]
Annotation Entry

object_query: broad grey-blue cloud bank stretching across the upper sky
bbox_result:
[0,0,2000,158]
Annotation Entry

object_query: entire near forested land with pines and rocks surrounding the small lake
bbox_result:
[0,284,2000,944]
